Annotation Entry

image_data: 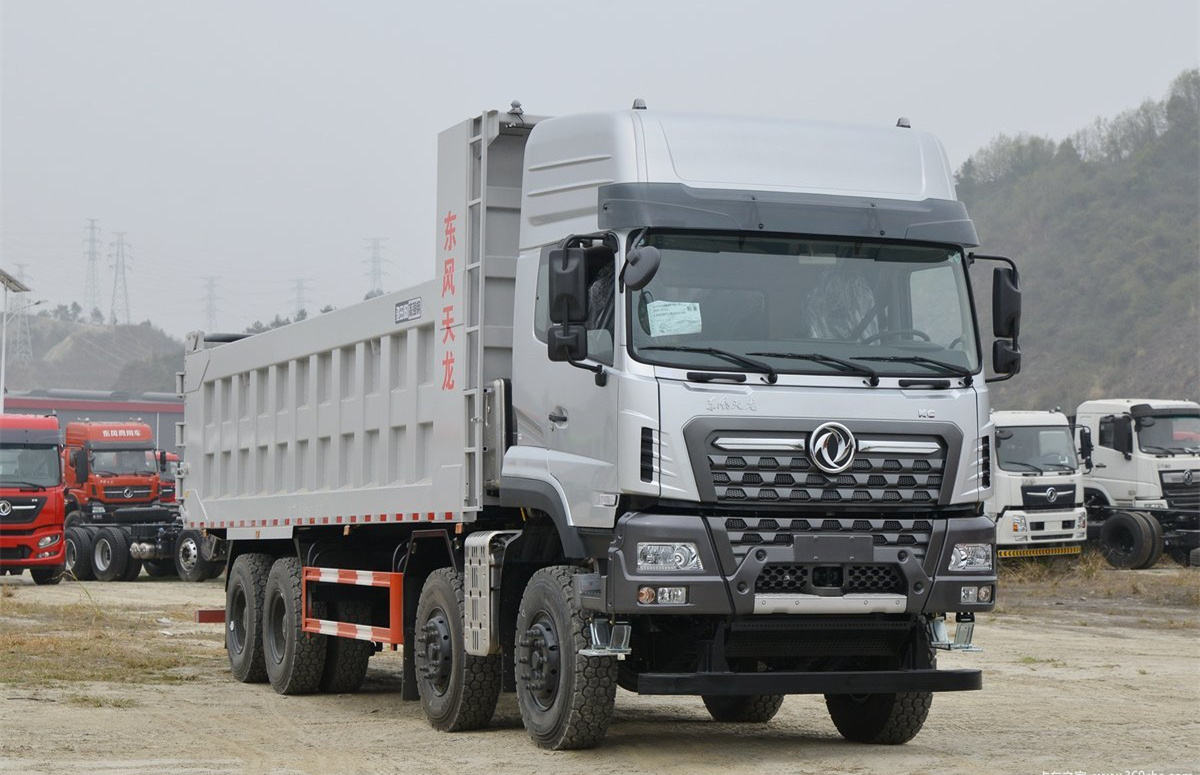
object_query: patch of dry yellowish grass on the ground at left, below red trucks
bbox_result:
[0,596,223,686]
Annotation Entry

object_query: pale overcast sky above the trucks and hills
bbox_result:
[0,0,1200,336]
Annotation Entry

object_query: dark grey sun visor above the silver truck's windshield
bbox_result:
[599,182,979,247]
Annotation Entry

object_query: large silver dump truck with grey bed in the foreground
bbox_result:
[178,103,1020,749]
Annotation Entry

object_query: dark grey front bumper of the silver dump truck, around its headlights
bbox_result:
[580,512,996,615]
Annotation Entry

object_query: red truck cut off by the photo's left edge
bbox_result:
[0,414,66,584]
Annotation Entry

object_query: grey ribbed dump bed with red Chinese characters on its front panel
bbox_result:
[176,112,535,539]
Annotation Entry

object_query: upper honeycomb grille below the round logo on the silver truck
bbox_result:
[708,437,946,506]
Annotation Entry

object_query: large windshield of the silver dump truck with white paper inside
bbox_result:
[628,230,979,378]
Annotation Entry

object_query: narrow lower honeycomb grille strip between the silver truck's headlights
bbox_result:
[713,517,934,560]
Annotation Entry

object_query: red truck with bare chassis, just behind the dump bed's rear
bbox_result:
[62,421,222,581]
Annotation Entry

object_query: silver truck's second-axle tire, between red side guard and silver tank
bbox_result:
[413,567,500,732]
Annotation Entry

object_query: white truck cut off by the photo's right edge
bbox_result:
[1074,398,1200,569]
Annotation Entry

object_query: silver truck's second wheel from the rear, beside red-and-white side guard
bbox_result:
[263,557,326,695]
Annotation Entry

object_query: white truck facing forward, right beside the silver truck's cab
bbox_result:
[985,410,1087,558]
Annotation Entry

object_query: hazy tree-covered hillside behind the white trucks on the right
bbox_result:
[958,70,1200,410]
